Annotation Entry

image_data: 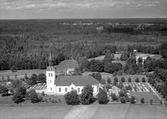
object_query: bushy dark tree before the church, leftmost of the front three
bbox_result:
[64,90,80,105]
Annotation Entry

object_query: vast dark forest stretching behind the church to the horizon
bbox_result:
[0,19,166,70]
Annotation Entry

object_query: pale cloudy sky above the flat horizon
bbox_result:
[0,0,167,19]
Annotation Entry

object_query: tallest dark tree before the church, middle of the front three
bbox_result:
[80,85,94,105]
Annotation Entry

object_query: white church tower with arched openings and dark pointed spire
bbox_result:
[46,52,56,94]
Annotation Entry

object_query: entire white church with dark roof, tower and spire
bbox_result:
[46,53,99,95]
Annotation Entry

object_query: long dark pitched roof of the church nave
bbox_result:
[55,76,99,86]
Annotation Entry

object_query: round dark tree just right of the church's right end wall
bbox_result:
[97,90,108,104]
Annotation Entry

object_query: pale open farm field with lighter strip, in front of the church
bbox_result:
[0,104,167,119]
